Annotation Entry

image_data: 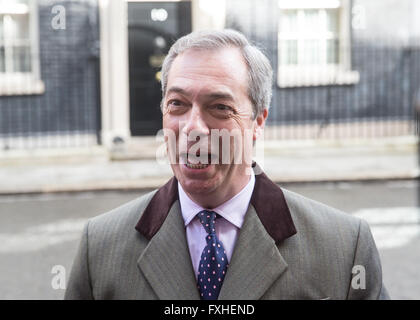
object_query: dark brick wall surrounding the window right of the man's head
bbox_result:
[226,0,420,124]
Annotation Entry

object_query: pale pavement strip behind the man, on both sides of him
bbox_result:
[0,136,419,194]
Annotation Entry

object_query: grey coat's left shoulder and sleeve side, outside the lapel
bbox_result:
[66,190,156,299]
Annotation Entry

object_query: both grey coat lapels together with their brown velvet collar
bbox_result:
[136,163,296,299]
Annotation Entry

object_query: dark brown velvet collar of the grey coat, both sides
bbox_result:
[136,162,296,244]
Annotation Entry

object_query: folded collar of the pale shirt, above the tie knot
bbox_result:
[178,171,255,229]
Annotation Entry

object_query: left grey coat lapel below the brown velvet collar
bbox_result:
[137,201,200,300]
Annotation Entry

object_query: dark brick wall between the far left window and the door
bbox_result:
[0,0,99,136]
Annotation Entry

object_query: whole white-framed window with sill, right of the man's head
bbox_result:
[278,0,359,87]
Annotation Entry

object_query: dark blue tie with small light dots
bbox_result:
[197,210,228,300]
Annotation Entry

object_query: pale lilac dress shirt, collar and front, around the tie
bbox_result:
[178,172,255,278]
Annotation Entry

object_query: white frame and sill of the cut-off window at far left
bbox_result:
[0,0,45,96]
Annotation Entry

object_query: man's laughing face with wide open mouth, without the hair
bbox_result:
[163,48,267,204]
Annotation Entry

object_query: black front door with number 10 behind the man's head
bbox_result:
[128,1,191,136]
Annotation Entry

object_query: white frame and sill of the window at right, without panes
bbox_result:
[277,0,360,88]
